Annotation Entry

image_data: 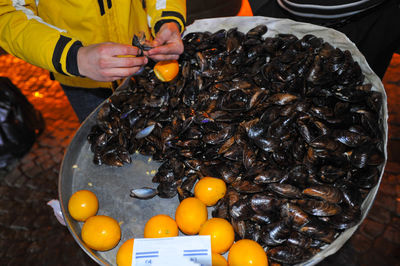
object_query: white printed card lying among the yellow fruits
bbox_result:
[132,236,211,266]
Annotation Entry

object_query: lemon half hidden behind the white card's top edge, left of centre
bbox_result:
[144,214,179,238]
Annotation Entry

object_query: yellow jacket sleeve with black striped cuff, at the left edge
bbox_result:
[0,1,81,75]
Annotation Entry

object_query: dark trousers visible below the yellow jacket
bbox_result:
[61,84,112,123]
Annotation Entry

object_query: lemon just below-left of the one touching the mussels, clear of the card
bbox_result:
[175,197,208,235]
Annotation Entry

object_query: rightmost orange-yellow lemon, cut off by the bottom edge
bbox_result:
[228,239,268,266]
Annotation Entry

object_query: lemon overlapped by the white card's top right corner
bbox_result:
[199,218,235,253]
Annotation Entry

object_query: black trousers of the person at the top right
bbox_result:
[249,0,400,79]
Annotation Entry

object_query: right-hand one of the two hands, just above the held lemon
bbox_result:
[147,22,183,61]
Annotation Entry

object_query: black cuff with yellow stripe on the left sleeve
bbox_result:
[52,35,83,76]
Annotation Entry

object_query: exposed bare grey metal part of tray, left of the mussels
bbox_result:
[59,93,179,265]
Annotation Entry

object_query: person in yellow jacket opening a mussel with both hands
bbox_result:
[0,0,186,122]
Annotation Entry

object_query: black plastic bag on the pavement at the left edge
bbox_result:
[0,77,45,169]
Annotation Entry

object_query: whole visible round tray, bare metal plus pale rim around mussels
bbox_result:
[59,17,388,265]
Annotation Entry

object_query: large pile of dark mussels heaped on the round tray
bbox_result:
[88,25,385,264]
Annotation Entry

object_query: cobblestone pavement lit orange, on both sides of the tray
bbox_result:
[0,52,400,265]
